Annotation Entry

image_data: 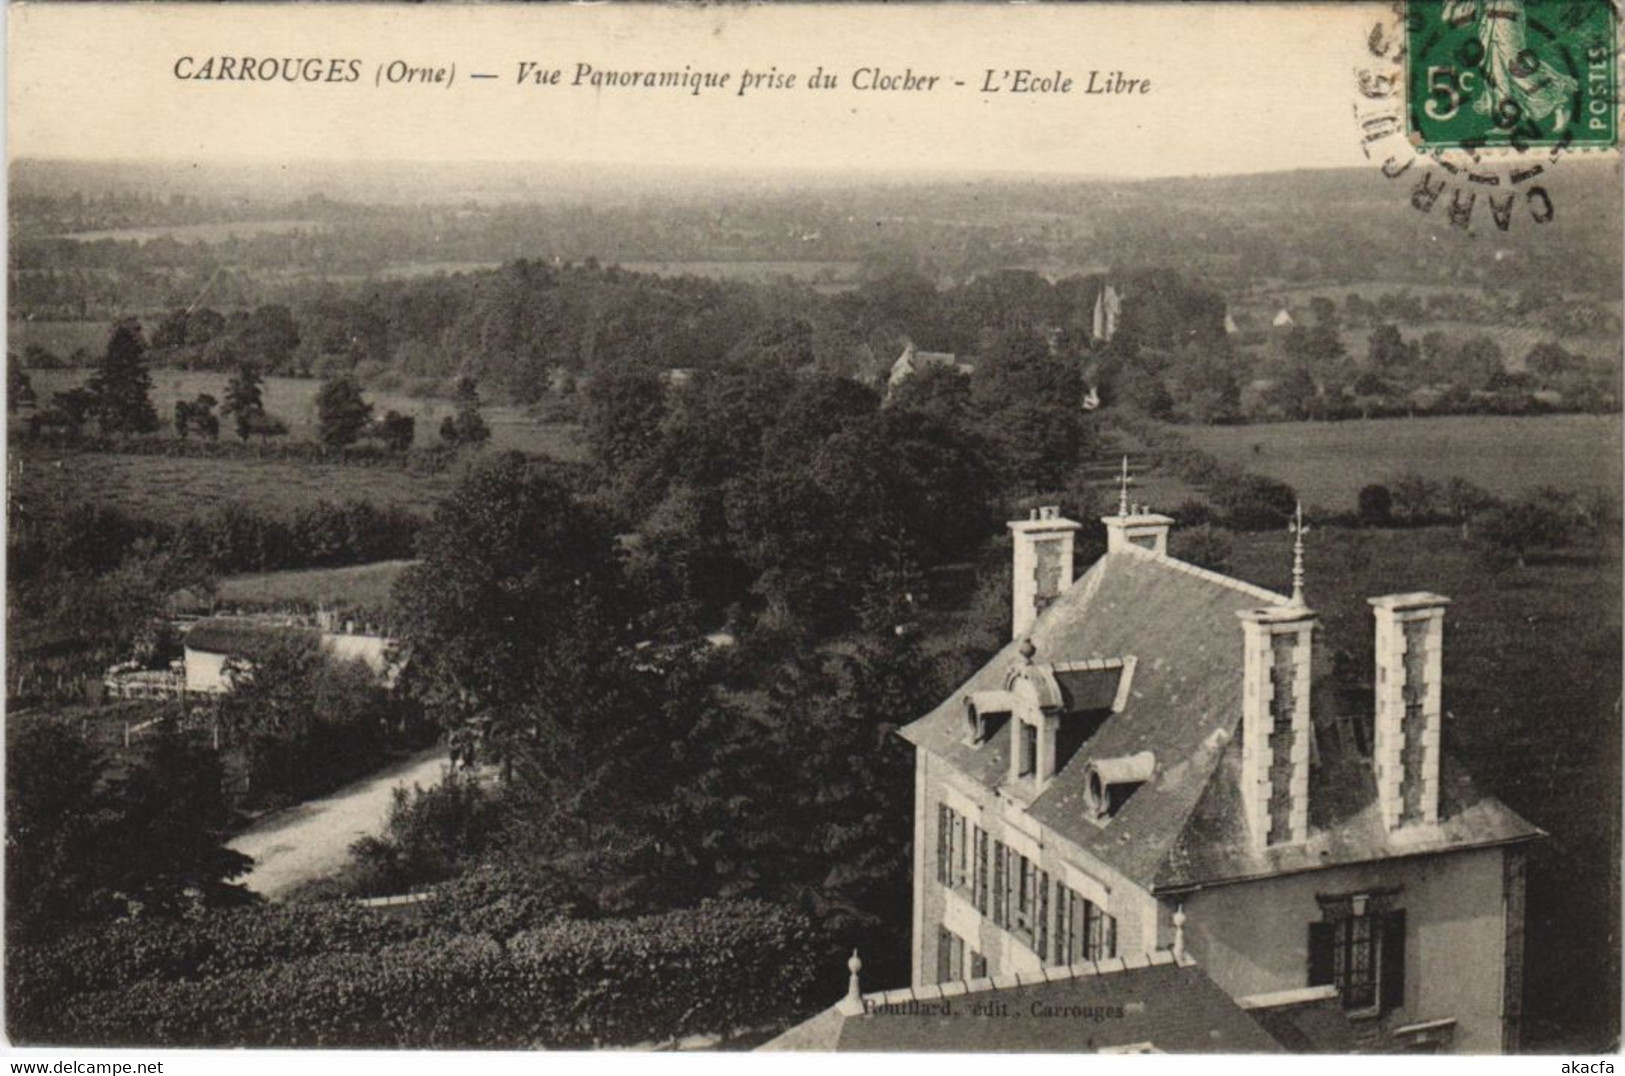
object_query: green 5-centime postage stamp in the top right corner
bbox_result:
[1406,0,1619,151]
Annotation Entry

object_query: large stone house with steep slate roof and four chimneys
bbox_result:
[904,503,1541,1053]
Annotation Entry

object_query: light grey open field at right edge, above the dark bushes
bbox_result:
[1181,414,1622,512]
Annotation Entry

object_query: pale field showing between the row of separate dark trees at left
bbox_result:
[29,368,585,460]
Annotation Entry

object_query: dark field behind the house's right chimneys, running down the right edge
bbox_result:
[1229,526,1622,1052]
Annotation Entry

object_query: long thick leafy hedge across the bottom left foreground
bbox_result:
[8,900,824,1048]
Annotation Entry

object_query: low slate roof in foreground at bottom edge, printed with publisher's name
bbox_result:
[761,951,1281,1053]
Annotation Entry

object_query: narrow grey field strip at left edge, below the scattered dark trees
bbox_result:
[11,445,457,520]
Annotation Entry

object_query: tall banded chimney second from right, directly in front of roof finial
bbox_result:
[1237,603,1318,850]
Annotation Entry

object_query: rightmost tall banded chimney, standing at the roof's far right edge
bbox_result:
[1370,593,1450,832]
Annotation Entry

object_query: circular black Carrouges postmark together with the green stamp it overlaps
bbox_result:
[1355,0,1620,232]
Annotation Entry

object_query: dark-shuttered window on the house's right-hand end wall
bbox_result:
[1310,896,1406,1016]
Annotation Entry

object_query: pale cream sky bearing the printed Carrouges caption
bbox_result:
[7,3,1391,177]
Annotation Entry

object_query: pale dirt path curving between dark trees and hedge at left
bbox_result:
[228,748,447,900]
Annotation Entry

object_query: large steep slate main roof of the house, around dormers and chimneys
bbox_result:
[902,546,1541,892]
